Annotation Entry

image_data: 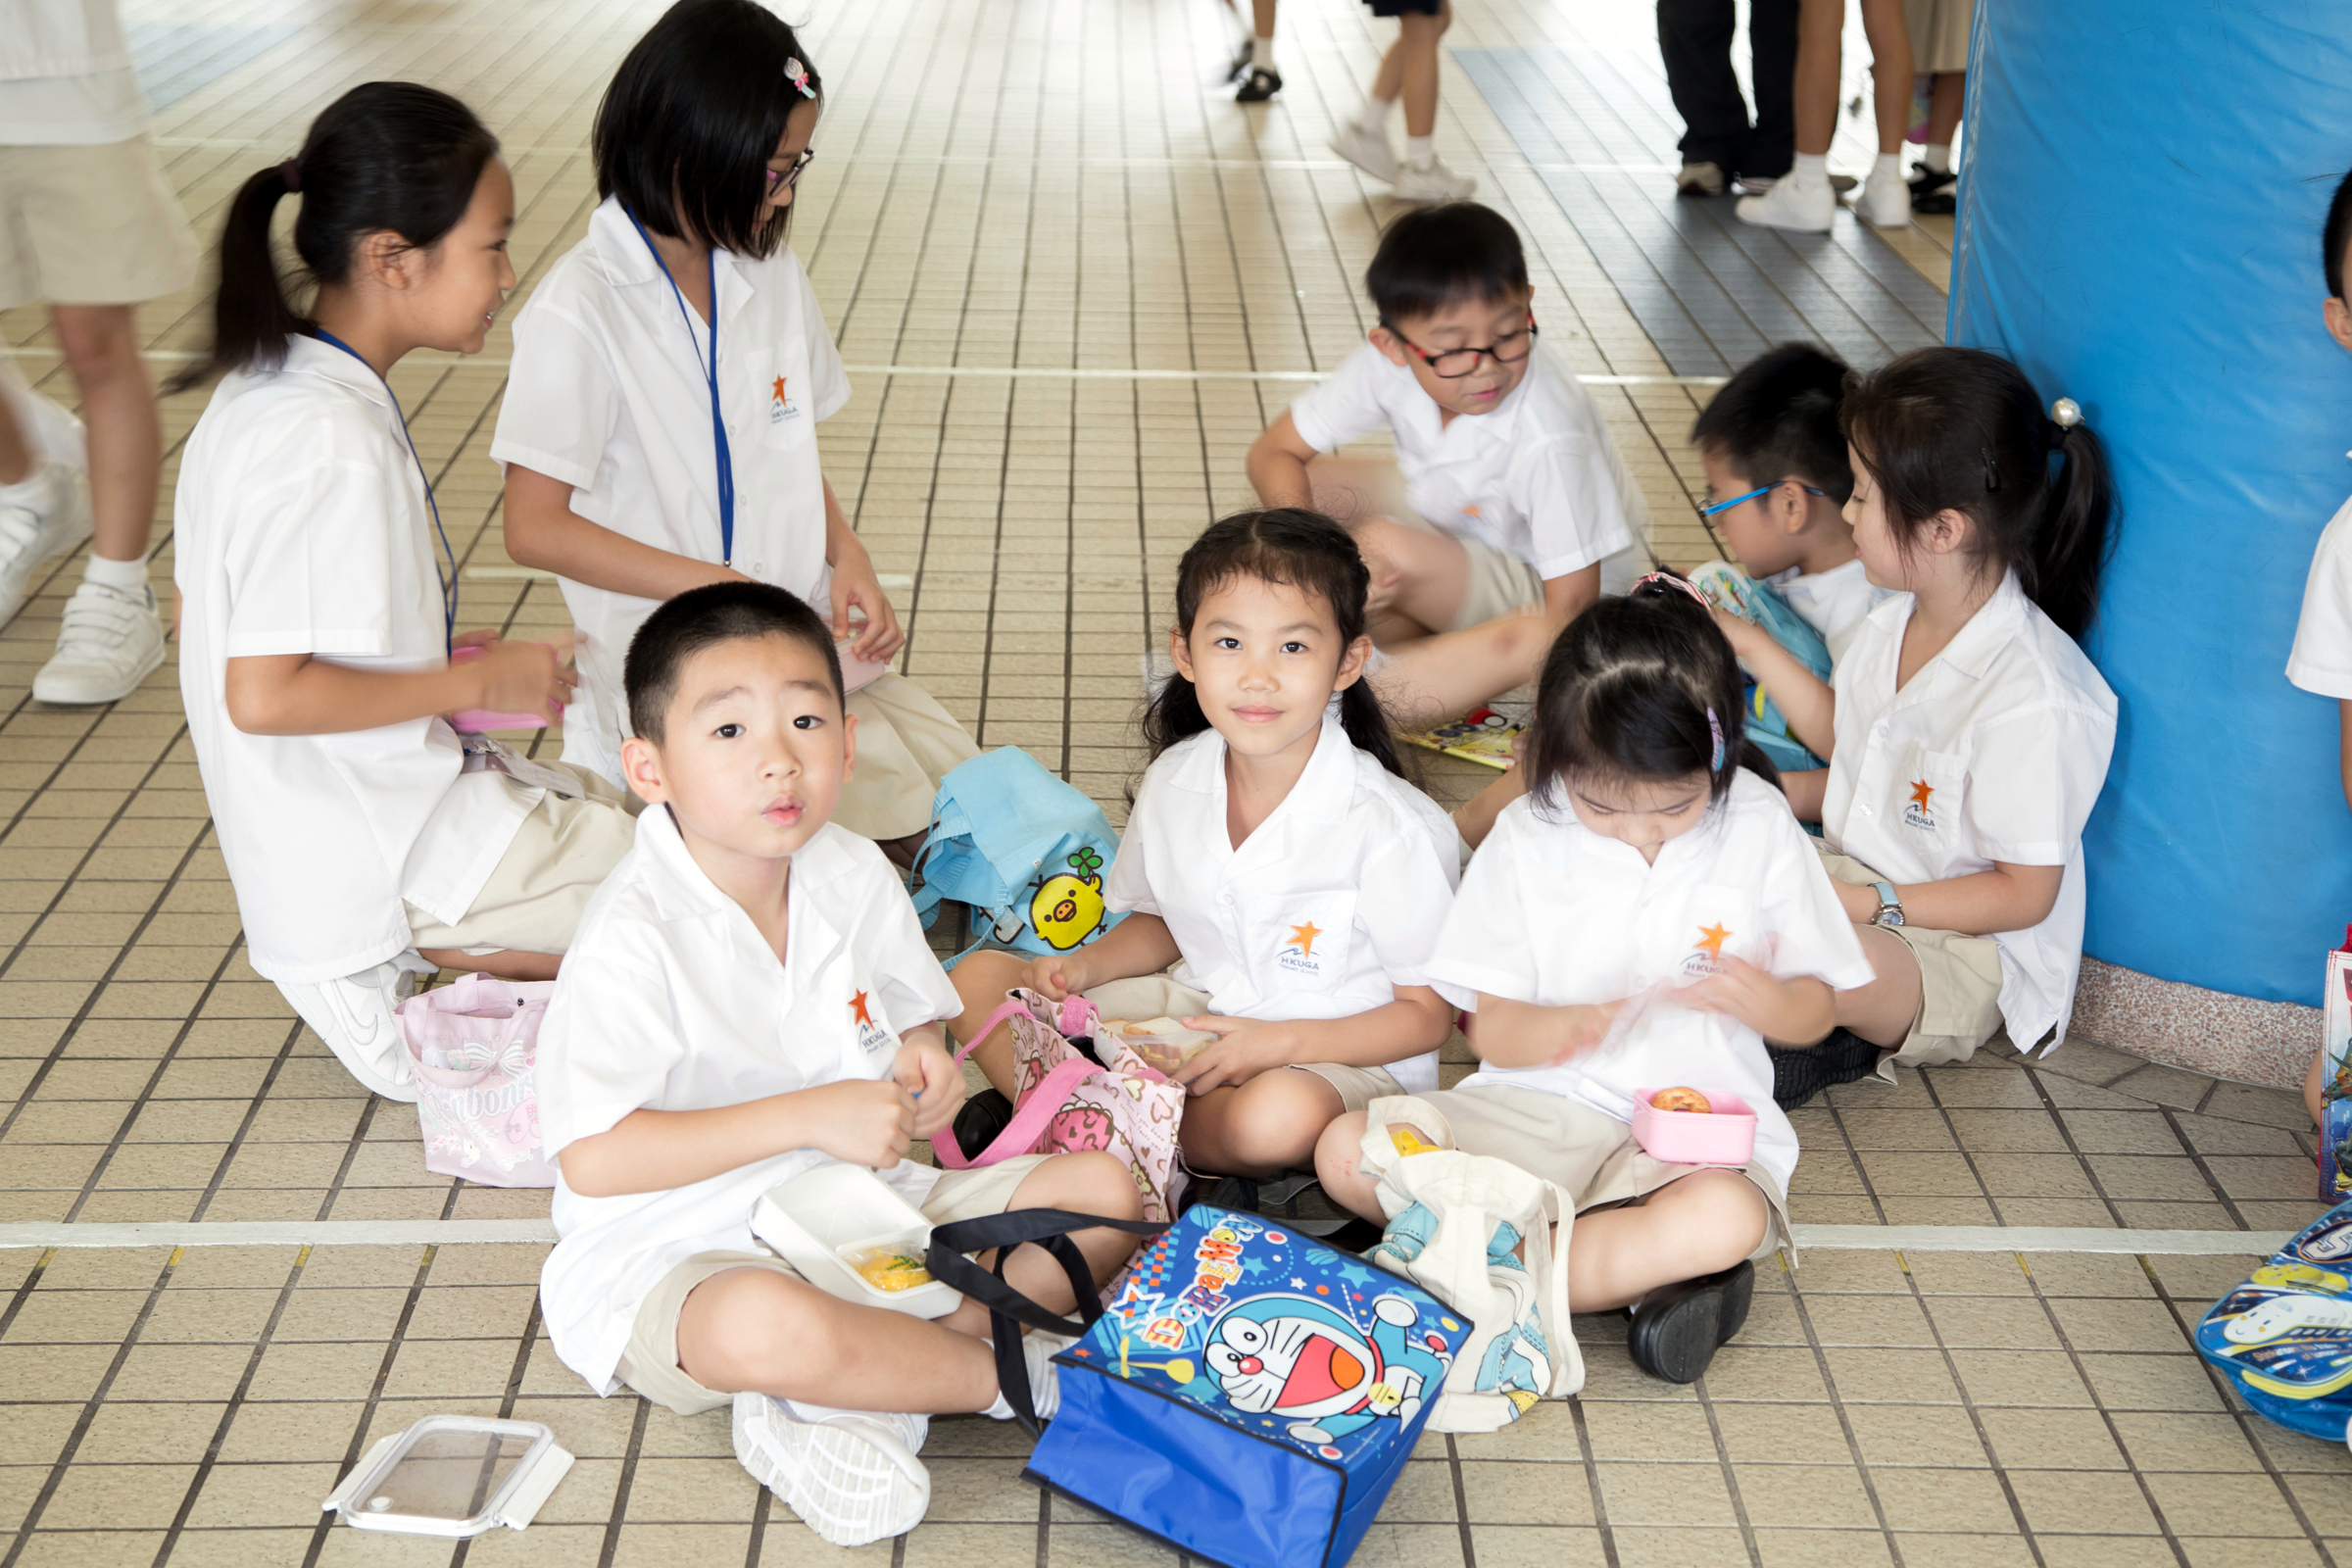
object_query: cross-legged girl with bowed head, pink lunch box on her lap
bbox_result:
[1315,576,1870,1382]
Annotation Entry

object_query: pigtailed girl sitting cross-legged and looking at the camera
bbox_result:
[955,508,1460,1175]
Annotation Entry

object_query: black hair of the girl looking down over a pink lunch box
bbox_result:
[1524,571,1781,813]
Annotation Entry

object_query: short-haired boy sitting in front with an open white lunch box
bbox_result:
[539,583,1141,1544]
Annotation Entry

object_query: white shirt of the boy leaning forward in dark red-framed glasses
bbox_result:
[1292,343,1648,578]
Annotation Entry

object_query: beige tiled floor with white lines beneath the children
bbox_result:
[0,0,2352,1568]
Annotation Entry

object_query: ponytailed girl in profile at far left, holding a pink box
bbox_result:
[174,82,633,1101]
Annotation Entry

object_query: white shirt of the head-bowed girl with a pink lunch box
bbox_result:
[1430,768,1872,1192]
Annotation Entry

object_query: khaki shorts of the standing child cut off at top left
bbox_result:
[0,136,195,311]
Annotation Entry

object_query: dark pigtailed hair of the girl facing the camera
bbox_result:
[1143,506,1411,778]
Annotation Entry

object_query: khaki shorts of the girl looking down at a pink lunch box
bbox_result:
[1413,1084,1797,1262]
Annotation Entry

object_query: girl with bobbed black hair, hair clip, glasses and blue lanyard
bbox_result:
[489,0,978,858]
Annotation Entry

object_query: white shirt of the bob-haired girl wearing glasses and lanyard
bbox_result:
[489,200,849,783]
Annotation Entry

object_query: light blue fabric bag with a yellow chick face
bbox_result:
[912,745,1122,968]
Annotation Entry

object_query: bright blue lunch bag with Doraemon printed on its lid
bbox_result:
[1025,1203,1470,1568]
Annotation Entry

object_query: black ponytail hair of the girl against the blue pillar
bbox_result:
[1839,348,2115,639]
